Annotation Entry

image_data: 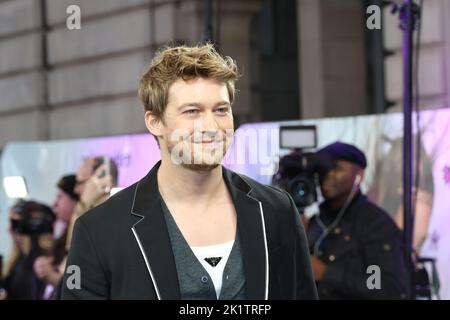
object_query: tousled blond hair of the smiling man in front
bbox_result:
[138,43,238,120]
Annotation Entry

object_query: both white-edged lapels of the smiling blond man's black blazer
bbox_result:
[131,162,269,300]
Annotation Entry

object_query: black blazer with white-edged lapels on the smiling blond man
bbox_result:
[62,163,317,300]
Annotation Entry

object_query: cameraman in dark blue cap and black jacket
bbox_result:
[307,142,405,299]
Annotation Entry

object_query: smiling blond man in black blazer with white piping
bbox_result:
[63,44,317,299]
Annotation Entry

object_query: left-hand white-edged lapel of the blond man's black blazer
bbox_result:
[131,163,181,300]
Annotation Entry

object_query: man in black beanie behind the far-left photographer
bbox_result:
[34,174,79,299]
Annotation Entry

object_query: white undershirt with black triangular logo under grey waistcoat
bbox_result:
[191,240,234,299]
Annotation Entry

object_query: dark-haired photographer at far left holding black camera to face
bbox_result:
[1,201,55,300]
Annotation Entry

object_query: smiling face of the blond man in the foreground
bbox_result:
[152,78,234,171]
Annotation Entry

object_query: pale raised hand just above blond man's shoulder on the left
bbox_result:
[80,164,112,207]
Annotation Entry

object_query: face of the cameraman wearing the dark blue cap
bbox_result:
[320,160,363,200]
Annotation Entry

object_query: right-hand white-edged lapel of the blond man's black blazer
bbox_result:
[223,168,269,300]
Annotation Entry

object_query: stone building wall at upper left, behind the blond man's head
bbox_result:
[0,0,260,148]
